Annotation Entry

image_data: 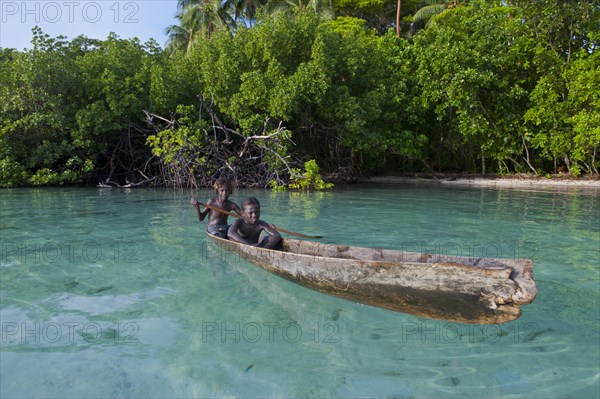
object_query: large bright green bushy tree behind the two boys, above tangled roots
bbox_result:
[176,12,426,172]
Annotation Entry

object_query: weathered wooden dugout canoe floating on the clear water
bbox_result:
[207,234,538,324]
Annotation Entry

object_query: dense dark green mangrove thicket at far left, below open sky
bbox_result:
[0,28,160,186]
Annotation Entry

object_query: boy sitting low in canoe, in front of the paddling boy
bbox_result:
[228,197,281,249]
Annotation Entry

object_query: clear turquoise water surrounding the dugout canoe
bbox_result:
[0,185,600,398]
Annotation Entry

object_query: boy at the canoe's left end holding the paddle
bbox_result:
[190,177,242,238]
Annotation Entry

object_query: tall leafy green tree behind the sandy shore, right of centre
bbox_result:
[415,3,532,172]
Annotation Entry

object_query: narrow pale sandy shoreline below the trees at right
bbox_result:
[362,174,600,190]
